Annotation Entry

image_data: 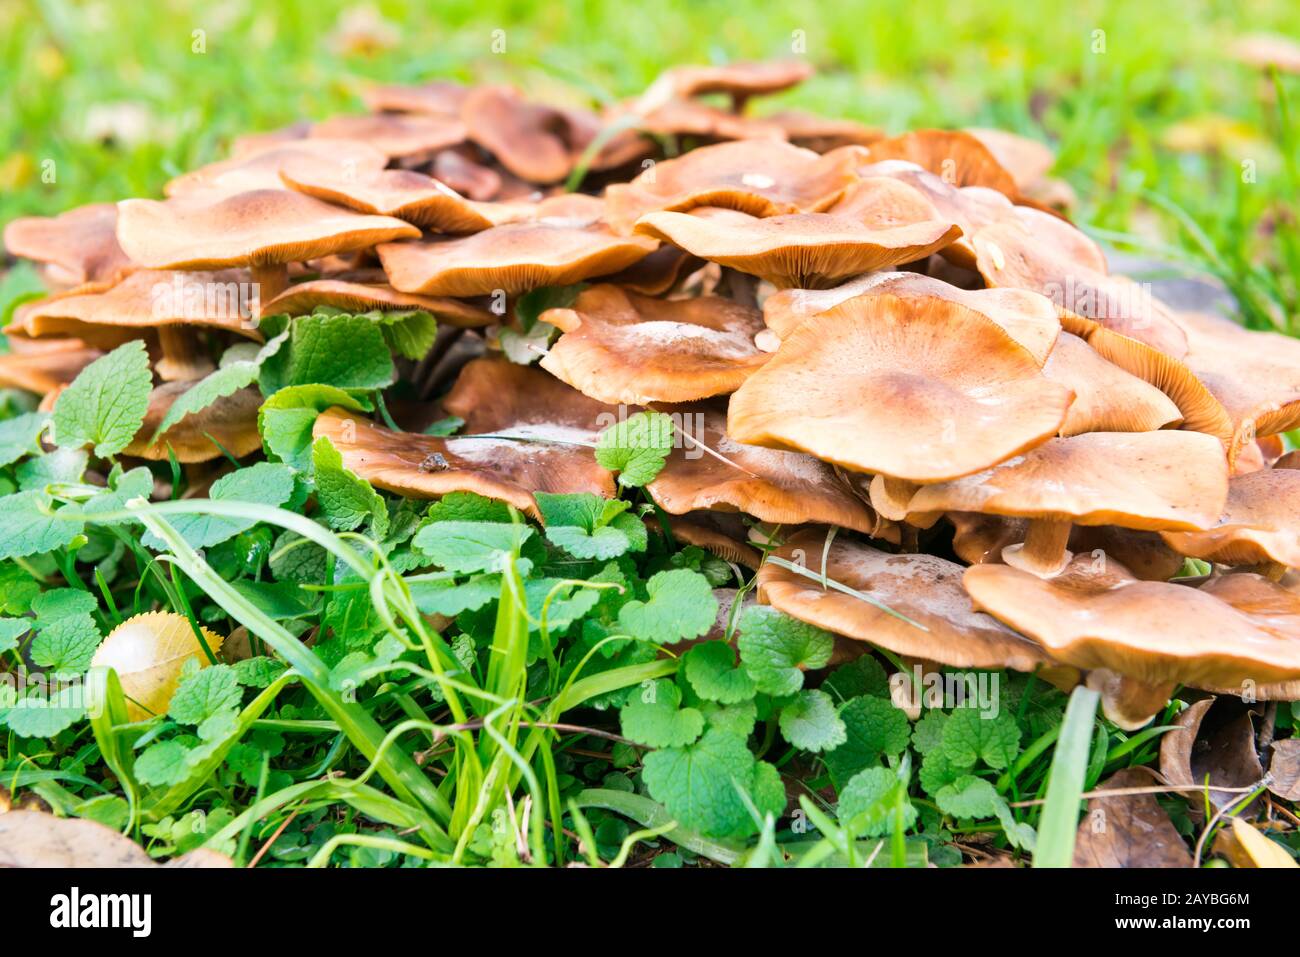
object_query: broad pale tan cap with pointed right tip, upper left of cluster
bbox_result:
[117,190,420,269]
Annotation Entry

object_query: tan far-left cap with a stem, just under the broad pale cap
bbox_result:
[10,269,261,347]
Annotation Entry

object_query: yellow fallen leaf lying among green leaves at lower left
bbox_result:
[91,611,224,720]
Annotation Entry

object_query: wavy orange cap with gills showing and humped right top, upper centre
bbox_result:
[636,178,961,287]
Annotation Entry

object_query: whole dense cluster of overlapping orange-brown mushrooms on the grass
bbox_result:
[0,62,1300,728]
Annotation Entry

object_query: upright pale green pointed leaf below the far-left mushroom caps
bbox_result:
[53,339,153,458]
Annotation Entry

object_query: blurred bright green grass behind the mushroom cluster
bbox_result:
[0,0,1300,325]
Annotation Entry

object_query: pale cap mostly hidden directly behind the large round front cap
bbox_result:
[763,272,1061,367]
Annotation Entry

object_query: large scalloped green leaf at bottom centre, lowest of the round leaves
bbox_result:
[642,728,764,837]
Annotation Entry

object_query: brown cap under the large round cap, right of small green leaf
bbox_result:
[646,403,883,534]
